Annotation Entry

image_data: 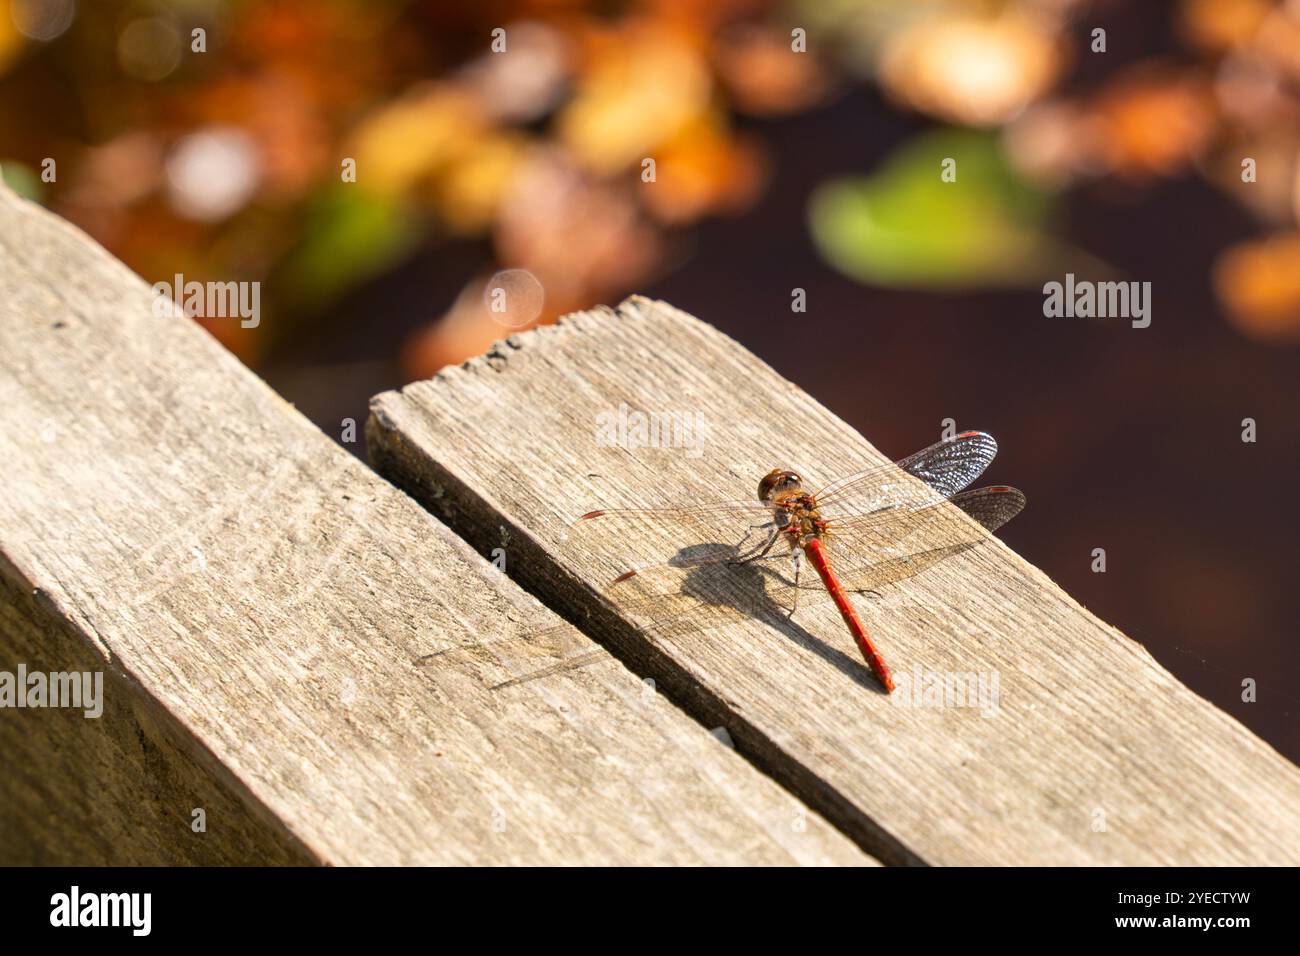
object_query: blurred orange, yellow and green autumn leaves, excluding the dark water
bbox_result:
[0,0,1300,361]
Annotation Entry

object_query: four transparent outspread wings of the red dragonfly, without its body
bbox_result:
[494,442,1024,687]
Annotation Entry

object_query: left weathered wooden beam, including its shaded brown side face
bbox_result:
[0,190,871,864]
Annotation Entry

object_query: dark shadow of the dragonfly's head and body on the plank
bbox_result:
[645,542,885,693]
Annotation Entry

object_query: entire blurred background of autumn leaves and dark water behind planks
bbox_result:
[0,0,1300,757]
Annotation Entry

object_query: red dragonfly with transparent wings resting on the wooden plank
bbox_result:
[428,432,1026,692]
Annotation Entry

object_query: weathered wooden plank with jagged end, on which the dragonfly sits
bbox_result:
[371,298,1300,864]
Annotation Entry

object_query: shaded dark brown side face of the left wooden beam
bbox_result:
[0,561,315,866]
